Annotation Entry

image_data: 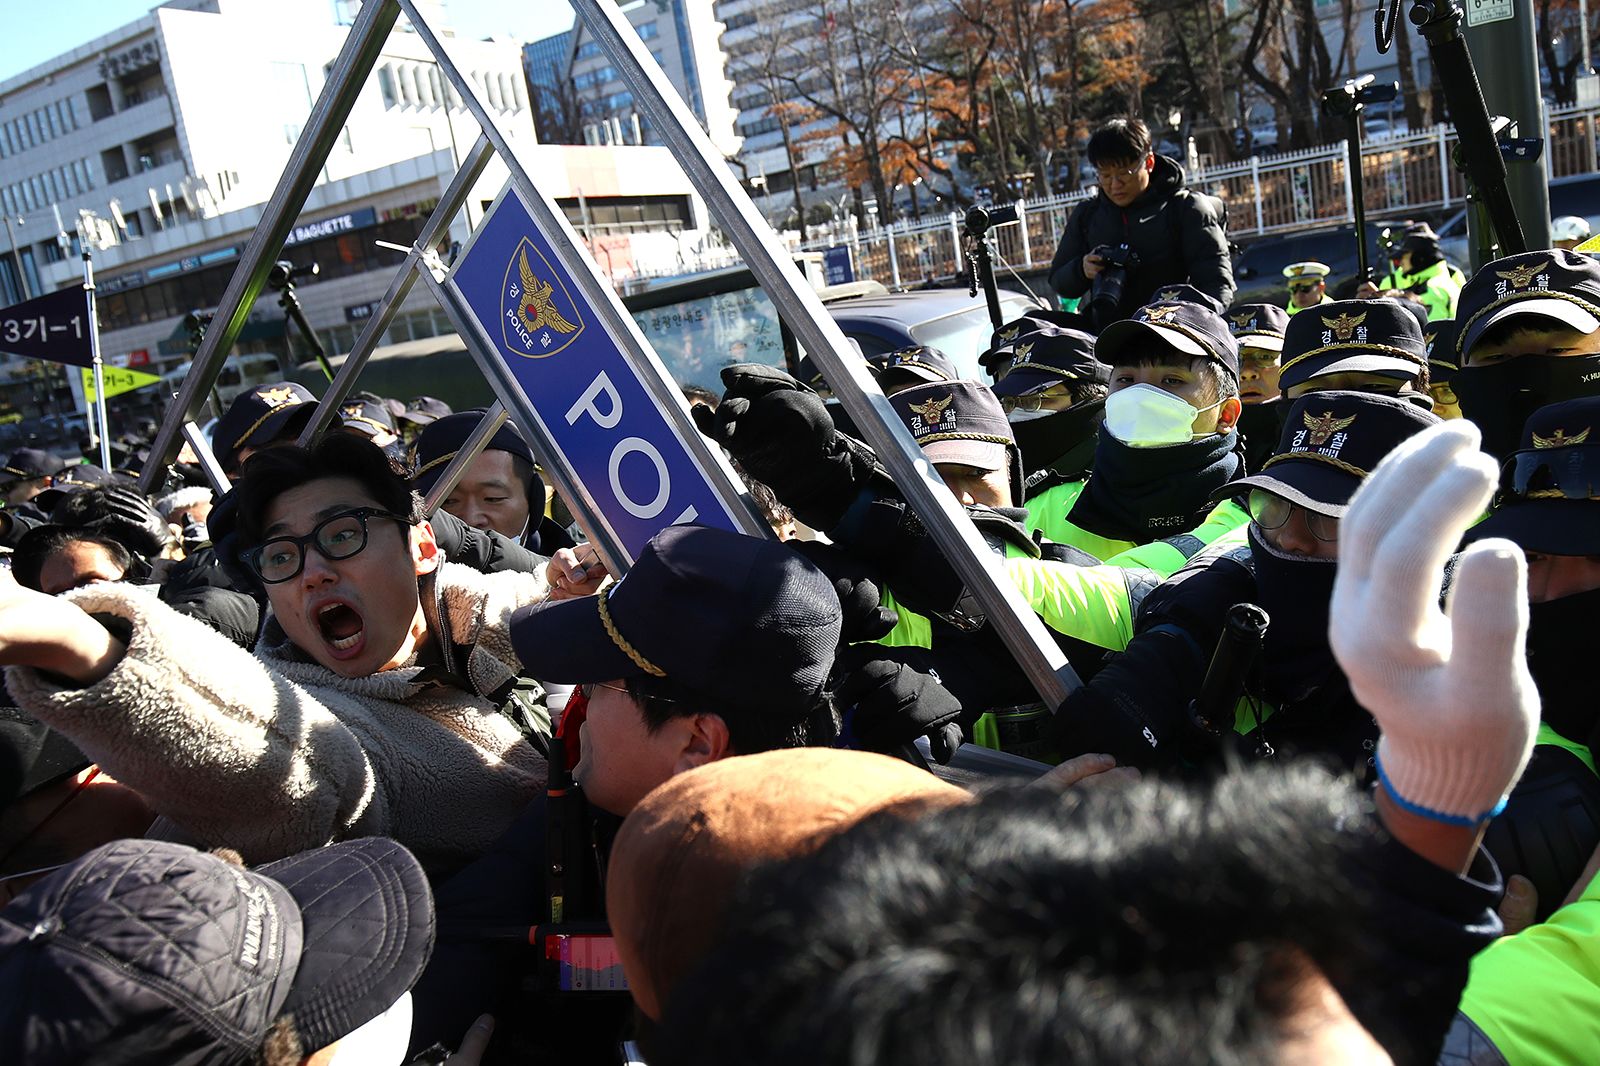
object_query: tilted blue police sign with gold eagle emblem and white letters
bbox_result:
[450,187,744,559]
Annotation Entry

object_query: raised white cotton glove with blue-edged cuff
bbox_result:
[1328,421,1539,826]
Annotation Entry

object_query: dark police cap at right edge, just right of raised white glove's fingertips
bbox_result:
[1467,395,1600,555]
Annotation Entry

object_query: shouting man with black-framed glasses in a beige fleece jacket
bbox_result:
[0,434,602,874]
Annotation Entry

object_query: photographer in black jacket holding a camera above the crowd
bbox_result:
[1050,118,1234,331]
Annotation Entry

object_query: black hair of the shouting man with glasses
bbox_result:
[234,434,426,549]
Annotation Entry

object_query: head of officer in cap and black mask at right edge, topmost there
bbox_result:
[1451,250,1600,459]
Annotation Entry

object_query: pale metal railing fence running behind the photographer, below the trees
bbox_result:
[803,104,1600,288]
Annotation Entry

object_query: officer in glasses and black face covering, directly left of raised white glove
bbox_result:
[1054,392,1440,773]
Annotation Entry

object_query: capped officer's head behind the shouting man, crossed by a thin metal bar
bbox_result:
[413,408,573,555]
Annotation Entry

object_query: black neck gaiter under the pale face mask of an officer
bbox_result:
[1069,432,1243,544]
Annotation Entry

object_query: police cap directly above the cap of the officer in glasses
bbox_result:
[1278,299,1427,394]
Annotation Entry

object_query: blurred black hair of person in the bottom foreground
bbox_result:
[650,767,1381,1066]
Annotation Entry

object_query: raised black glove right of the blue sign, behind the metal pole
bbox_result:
[691,363,877,530]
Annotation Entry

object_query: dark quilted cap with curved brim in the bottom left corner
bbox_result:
[0,839,434,1066]
